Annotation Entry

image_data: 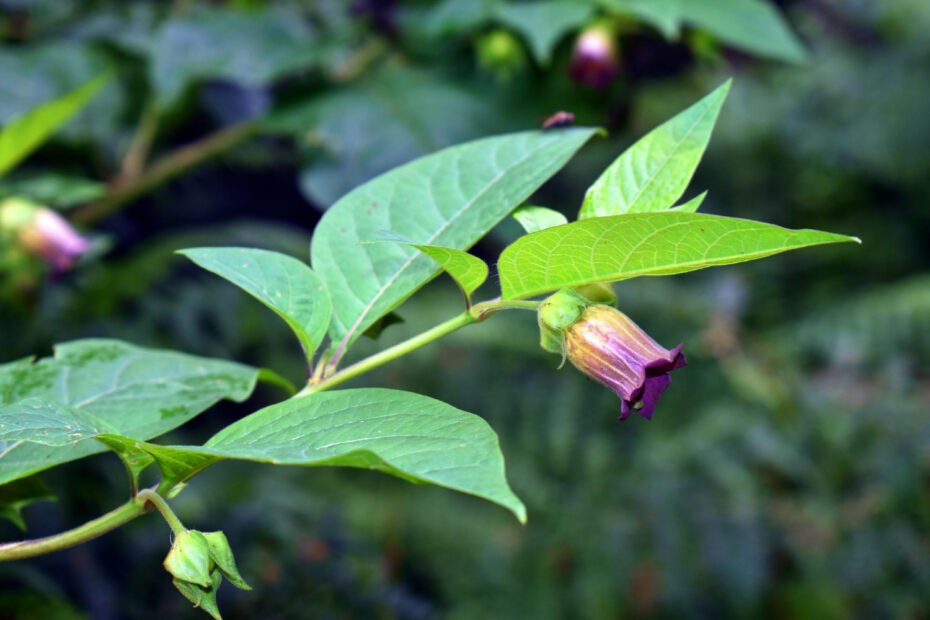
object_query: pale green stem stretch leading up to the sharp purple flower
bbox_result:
[297,300,539,396]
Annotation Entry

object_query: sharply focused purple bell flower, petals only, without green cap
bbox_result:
[565,305,687,420]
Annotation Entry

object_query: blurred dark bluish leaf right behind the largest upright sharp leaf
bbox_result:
[264,65,497,208]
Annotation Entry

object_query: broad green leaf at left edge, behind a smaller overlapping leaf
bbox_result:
[0,340,258,483]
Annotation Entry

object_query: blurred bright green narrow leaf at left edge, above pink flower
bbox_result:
[0,76,109,176]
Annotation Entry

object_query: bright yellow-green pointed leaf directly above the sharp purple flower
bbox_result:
[498,212,859,299]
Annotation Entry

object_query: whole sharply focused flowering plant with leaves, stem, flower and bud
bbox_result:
[0,83,858,618]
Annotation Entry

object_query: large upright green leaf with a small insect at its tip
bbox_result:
[312,128,595,357]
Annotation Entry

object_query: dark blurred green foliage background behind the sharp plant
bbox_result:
[0,0,930,619]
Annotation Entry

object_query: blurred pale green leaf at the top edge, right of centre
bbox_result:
[601,0,806,63]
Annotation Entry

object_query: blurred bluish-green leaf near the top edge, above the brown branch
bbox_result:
[149,7,320,108]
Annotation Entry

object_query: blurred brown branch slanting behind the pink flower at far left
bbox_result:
[74,122,258,225]
